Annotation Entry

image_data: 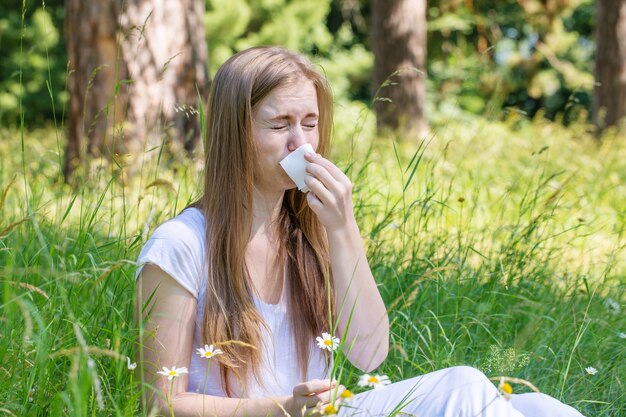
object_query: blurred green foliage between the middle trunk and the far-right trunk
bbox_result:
[428,0,595,124]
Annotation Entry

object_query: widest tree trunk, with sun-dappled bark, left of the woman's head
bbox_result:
[65,0,208,179]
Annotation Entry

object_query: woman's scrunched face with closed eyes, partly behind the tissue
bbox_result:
[252,78,319,192]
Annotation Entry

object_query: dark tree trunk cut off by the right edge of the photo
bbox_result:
[592,0,626,133]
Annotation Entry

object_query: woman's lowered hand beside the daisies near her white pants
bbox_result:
[285,379,345,417]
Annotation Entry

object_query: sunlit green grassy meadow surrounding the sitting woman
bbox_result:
[0,105,626,417]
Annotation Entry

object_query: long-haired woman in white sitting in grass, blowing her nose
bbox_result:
[137,47,580,417]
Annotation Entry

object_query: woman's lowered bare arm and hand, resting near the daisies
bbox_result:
[136,264,330,417]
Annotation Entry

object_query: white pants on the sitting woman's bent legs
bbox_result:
[339,366,582,417]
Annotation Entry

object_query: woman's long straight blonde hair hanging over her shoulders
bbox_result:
[194,47,334,396]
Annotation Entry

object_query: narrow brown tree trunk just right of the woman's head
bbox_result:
[372,0,427,134]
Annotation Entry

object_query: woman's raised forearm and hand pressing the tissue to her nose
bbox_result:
[305,154,389,372]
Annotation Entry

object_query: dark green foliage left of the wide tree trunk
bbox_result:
[0,0,67,125]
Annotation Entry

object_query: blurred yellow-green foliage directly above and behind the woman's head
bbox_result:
[205,0,373,101]
